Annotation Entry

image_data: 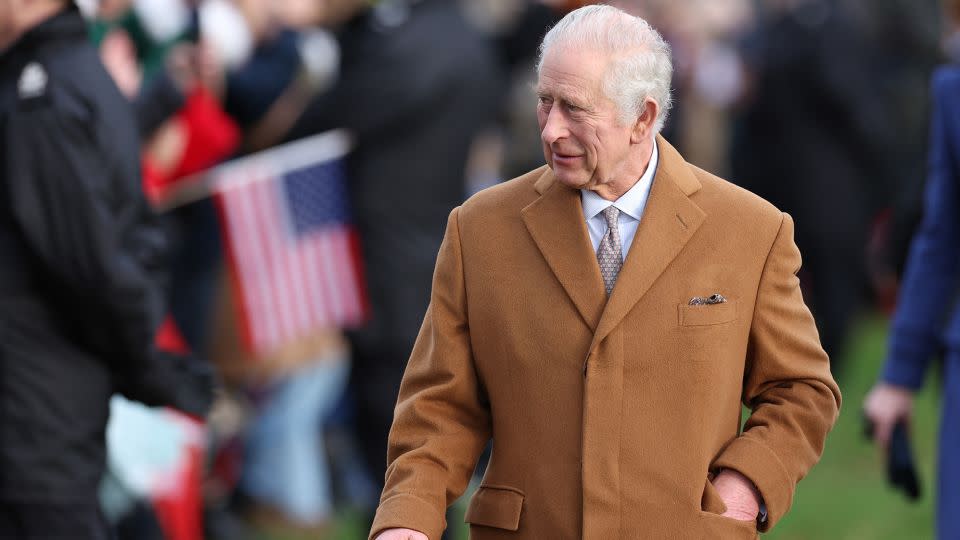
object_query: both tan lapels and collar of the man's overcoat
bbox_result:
[521,135,706,351]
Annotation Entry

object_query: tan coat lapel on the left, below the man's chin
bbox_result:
[521,169,607,332]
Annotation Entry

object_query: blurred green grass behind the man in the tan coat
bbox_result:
[335,318,939,540]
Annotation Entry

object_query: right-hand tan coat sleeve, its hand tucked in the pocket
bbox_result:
[712,214,840,529]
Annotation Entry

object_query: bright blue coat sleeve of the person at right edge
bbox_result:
[882,69,960,390]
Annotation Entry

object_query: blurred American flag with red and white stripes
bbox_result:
[214,132,367,354]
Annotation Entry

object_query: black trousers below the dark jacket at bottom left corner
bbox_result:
[0,502,112,540]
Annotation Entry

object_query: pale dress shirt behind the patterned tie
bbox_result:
[580,142,660,260]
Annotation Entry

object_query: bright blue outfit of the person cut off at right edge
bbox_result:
[882,66,960,540]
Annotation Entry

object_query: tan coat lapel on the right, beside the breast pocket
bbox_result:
[581,136,705,351]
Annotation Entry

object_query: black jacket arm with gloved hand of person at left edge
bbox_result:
[7,101,214,415]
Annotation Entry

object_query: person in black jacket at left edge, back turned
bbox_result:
[0,0,212,539]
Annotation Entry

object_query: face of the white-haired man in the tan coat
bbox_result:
[537,45,643,195]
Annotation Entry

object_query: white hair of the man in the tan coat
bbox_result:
[537,5,673,133]
